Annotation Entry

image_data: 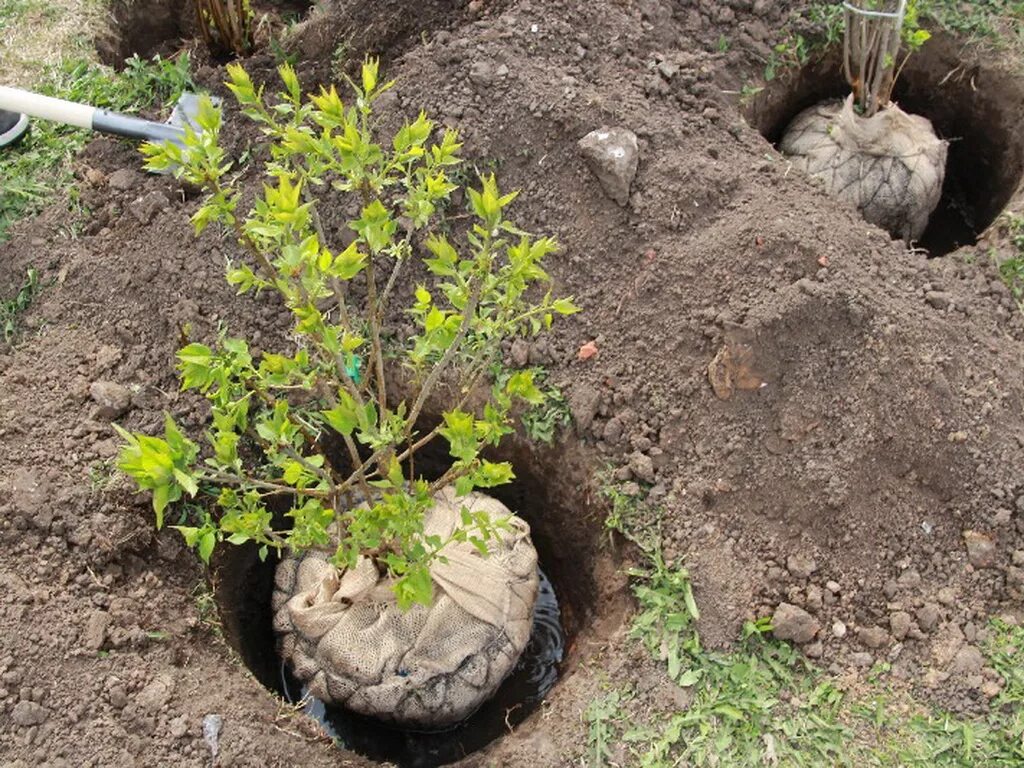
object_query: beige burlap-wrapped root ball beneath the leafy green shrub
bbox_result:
[272,487,539,729]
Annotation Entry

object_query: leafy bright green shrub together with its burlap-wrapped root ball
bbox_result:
[119,60,577,727]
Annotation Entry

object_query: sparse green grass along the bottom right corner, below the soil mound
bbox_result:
[598,485,1024,768]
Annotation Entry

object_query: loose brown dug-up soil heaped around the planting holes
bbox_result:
[0,0,1024,768]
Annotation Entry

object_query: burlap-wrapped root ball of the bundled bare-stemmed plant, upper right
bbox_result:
[779,95,948,243]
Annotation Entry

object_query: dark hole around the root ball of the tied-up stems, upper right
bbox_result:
[745,34,1024,256]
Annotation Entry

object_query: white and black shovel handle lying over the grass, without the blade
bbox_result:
[0,85,184,141]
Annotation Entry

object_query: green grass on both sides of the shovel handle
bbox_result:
[0,54,194,242]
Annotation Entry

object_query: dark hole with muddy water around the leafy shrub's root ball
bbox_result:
[214,424,616,768]
